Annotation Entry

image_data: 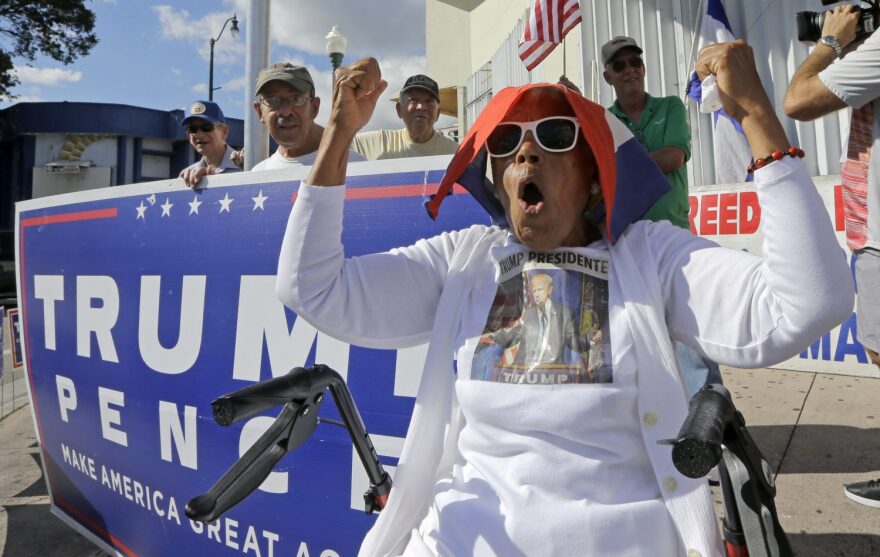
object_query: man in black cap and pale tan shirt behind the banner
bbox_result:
[352,74,458,160]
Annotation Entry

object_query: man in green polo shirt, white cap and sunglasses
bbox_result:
[602,37,691,229]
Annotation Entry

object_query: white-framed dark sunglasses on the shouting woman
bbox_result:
[486,116,580,158]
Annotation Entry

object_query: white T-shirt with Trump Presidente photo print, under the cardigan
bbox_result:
[406,243,681,556]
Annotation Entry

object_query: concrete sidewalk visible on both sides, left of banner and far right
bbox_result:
[0,368,880,557]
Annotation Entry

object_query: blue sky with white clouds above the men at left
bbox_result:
[0,0,452,129]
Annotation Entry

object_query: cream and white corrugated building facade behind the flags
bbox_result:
[427,0,849,186]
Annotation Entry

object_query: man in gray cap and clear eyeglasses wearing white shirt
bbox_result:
[252,62,364,170]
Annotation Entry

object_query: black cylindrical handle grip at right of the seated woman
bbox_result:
[672,383,735,478]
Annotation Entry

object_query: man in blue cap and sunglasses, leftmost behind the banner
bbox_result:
[180,101,241,188]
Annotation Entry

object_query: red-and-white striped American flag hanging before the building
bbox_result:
[519,0,581,71]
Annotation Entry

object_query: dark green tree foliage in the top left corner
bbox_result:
[0,0,98,98]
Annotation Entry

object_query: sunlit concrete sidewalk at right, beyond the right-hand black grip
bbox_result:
[722,366,880,557]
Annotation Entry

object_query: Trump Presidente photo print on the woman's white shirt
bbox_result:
[471,252,612,385]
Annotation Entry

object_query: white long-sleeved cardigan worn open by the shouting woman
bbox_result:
[277,159,853,556]
